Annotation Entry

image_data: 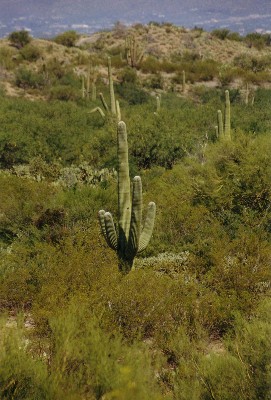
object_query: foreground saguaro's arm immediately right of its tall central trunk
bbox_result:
[127,176,142,258]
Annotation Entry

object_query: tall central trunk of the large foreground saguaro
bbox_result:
[118,121,131,252]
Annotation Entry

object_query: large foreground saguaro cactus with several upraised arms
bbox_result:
[99,121,156,273]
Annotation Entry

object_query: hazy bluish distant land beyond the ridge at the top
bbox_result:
[0,0,271,37]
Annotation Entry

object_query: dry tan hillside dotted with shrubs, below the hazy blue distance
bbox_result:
[0,24,271,101]
